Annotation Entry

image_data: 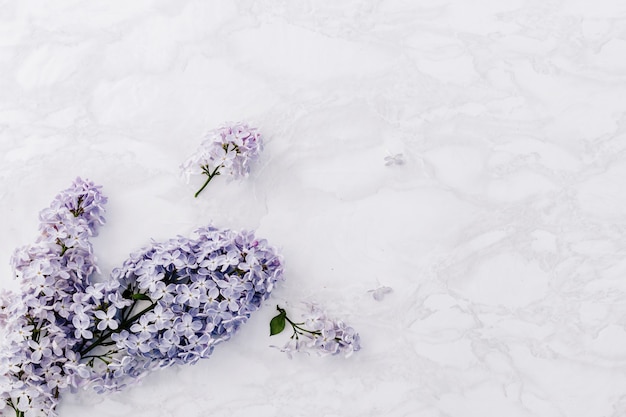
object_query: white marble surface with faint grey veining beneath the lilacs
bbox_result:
[0,0,626,417]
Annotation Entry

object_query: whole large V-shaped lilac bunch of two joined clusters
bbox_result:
[0,179,282,417]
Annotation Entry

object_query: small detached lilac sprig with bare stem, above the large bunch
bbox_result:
[181,123,263,197]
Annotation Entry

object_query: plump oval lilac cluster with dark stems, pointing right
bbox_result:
[82,226,283,390]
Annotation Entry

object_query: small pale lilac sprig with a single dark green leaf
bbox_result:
[270,305,361,358]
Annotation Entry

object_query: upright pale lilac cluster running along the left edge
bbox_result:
[0,178,106,417]
